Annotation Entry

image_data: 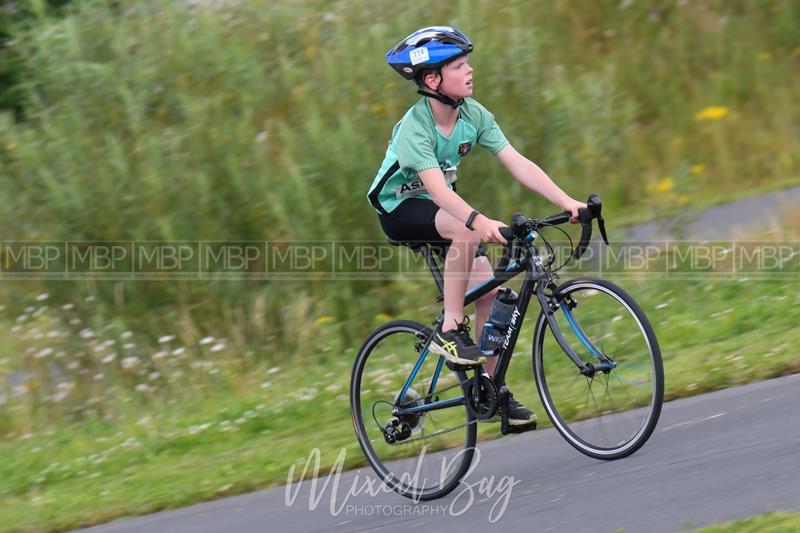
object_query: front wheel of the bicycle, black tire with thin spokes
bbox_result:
[533,278,664,459]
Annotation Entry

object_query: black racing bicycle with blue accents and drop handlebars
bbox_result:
[350,194,664,501]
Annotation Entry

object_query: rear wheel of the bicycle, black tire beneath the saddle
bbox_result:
[350,320,477,501]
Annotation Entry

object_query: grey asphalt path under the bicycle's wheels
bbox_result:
[78,375,800,533]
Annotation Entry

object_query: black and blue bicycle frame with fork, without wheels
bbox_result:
[394,232,616,415]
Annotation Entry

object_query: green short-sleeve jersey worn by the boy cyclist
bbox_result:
[367,97,508,213]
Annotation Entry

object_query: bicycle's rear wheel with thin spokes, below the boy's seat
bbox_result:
[351,325,475,497]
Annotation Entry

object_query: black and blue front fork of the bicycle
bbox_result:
[536,281,617,378]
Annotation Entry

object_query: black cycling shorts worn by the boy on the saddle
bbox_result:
[378,198,486,257]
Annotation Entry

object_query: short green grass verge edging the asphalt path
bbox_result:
[0,270,800,530]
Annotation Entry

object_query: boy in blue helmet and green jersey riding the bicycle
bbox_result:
[367,26,586,425]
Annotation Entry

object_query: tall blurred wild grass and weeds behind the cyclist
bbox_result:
[0,0,800,435]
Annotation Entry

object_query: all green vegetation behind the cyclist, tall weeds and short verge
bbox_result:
[0,0,800,530]
